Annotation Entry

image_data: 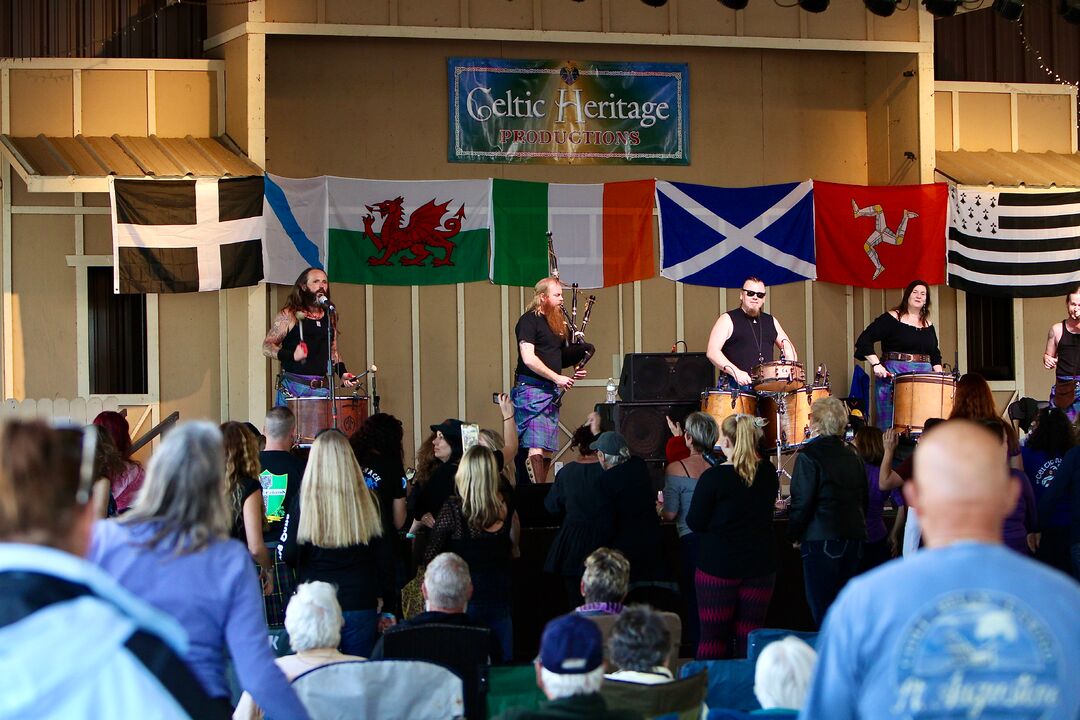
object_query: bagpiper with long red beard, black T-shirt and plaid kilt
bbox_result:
[510,277,592,483]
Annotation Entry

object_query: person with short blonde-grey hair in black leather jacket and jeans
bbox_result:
[787,397,869,627]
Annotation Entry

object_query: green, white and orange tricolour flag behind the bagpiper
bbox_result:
[490,179,656,288]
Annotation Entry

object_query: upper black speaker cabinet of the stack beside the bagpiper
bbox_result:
[619,353,716,403]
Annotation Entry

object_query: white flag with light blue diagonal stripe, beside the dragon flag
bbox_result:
[262,173,327,285]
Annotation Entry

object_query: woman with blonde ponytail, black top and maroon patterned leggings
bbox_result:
[686,413,779,660]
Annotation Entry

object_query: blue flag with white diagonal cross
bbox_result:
[657,180,818,287]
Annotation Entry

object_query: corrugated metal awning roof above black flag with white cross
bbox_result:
[0,135,262,191]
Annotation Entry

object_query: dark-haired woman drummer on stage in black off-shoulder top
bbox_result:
[855,280,942,430]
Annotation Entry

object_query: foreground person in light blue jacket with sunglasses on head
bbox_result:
[0,422,228,718]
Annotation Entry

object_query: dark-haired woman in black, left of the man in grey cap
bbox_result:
[543,424,613,610]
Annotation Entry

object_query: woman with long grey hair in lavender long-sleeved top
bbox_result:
[87,421,308,718]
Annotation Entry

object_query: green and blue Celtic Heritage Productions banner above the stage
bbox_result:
[447,57,690,165]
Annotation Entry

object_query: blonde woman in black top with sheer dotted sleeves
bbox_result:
[424,445,514,661]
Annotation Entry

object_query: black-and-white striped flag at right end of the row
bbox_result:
[948,186,1080,298]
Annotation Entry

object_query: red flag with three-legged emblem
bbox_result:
[813,180,948,289]
